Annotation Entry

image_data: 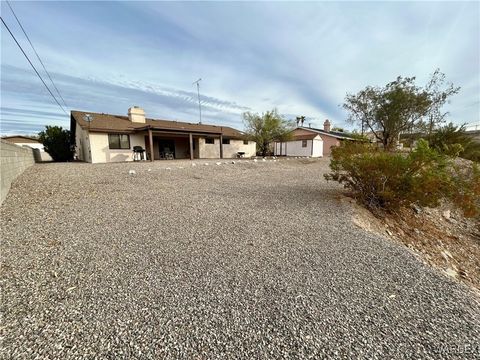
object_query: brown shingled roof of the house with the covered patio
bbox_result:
[71,110,248,138]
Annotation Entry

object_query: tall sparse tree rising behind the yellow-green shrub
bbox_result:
[343,70,460,150]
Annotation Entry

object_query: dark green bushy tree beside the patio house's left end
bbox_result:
[38,125,73,161]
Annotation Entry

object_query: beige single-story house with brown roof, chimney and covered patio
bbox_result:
[70,106,256,163]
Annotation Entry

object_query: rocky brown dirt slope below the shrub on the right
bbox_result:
[345,197,480,295]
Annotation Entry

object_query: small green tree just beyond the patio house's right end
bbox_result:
[243,109,294,156]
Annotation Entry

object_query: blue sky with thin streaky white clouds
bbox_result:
[0,1,480,135]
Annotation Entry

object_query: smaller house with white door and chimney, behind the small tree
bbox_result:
[273,119,352,157]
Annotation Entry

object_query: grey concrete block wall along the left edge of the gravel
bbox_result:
[0,140,35,204]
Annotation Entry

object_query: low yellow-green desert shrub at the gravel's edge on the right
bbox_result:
[325,140,480,216]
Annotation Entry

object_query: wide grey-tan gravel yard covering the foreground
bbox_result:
[0,159,480,359]
